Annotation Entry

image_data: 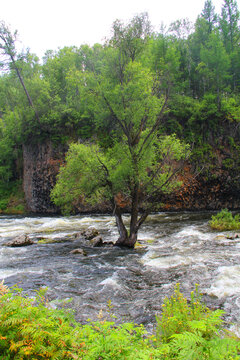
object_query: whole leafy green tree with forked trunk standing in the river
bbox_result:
[52,14,189,247]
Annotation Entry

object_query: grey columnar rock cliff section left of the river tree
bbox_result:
[23,142,66,213]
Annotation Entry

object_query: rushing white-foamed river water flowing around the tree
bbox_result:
[0,212,240,331]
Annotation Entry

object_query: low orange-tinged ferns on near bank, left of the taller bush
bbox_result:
[0,283,160,360]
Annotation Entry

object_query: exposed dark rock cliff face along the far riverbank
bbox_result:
[23,142,240,214]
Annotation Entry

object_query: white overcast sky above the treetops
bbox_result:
[0,0,227,58]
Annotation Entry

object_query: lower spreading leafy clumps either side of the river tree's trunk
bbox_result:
[51,136,188,213]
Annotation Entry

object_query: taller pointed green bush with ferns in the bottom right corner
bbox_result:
[157,284,240,360]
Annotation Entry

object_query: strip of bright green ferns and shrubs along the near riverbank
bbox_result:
[0,282,240,360]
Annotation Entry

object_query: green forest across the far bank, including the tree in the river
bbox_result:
[0,0,240,246]
